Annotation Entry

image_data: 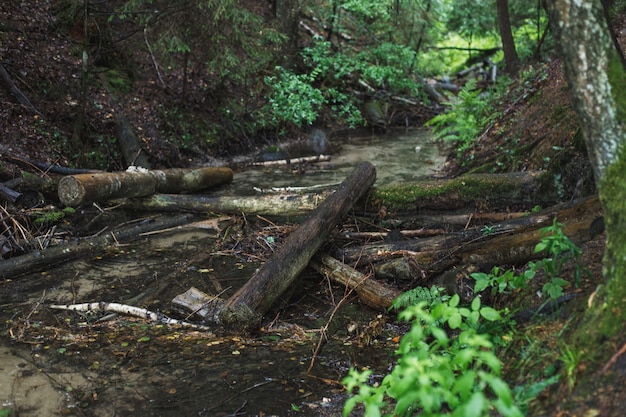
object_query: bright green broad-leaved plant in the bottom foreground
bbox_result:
[343,295,522,416]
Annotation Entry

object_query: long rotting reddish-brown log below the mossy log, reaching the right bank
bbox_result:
[348,197,604,285]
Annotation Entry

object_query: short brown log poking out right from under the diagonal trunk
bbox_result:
[309,254,401,310]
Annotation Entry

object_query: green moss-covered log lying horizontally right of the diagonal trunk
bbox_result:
[373,172,558,211]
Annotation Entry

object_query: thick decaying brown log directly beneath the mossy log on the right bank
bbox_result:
[370,197,604,280]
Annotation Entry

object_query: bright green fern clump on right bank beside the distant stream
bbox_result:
[426,79,487,156]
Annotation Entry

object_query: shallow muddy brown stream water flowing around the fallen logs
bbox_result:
[0,132,444,417]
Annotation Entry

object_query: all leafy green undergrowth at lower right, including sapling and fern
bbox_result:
[343,219,582,417]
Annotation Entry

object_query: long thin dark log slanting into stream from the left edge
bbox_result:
[0,215,191,279]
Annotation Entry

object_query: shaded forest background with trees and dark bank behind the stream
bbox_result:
[0,0,580,175]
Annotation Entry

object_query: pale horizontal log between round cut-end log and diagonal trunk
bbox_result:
[124,191,331,216]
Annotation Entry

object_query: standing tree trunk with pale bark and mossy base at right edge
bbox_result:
[546,0,626,390]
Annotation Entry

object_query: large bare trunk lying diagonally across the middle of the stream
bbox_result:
[219,162,376,329]
